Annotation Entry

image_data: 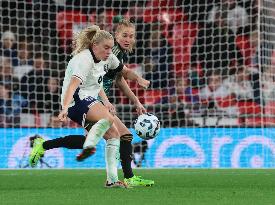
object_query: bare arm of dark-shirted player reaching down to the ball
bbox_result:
[116,75,146,115]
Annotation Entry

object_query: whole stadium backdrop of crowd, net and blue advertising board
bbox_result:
[0,0,275,168]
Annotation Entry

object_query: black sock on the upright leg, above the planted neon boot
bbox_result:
[119,134,134,179]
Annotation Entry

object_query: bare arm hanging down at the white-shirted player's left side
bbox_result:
[58,76,81,122]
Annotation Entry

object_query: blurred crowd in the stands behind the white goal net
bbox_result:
[0,0,275,127]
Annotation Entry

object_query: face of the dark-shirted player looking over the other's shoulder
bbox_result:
[116,26,135,51]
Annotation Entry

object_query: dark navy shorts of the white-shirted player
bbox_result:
[68,88,99,127]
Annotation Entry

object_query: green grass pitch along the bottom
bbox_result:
[0,169,275,205]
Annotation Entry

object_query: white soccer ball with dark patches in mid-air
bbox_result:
[134,113,160,140]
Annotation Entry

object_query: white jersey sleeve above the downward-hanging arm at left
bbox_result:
[72,56,92,83]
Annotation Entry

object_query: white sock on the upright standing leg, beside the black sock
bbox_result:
[105,138,120,183]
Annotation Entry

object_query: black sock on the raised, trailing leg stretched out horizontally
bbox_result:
[43,135,85,150]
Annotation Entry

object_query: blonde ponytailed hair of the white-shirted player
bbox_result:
[72,25,114,55]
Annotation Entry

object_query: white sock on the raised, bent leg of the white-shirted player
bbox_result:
[83,119,111,149]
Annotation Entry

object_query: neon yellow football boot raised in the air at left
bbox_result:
[29,137,45,167]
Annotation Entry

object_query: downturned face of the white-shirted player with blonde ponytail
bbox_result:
[93,39,114,61]
